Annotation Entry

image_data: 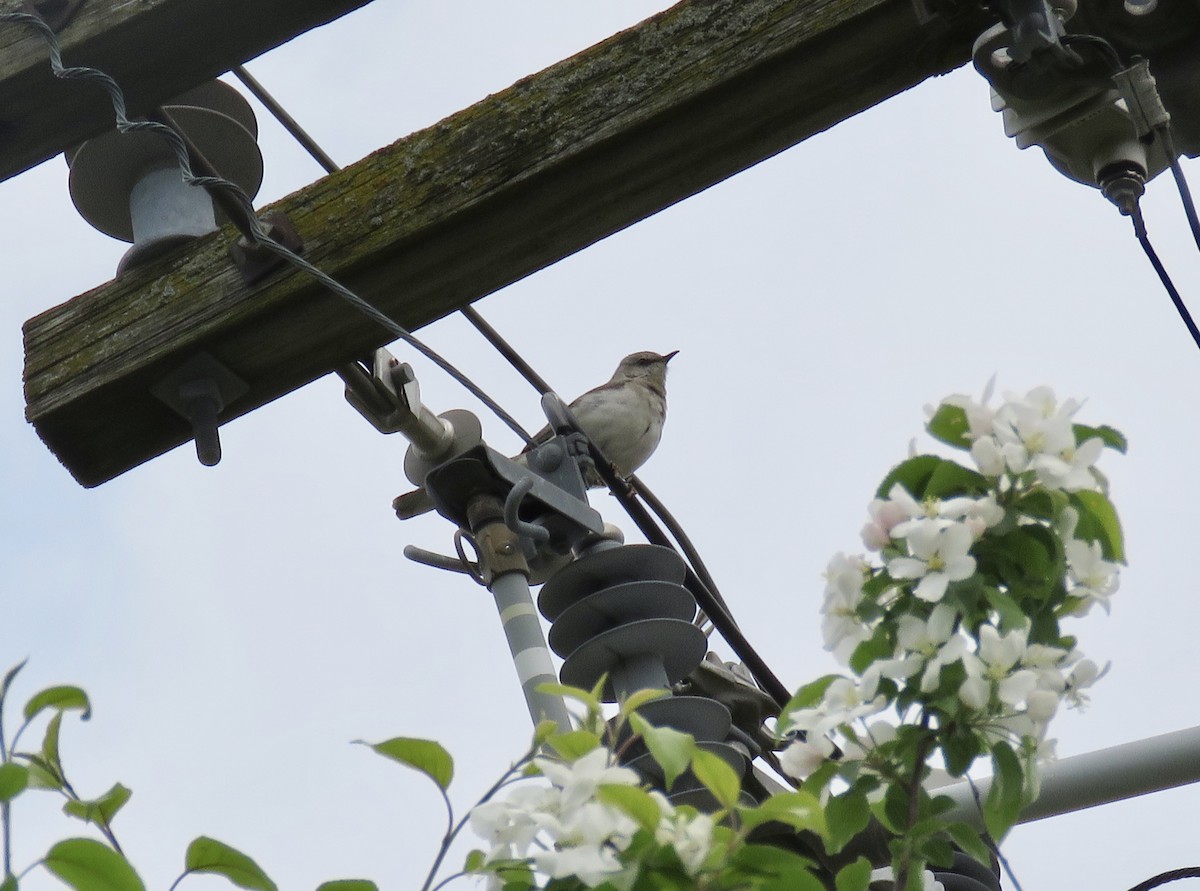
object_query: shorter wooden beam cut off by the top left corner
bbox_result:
[0,0,368,180]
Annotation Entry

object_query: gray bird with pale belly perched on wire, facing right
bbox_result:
[394,349,679,516]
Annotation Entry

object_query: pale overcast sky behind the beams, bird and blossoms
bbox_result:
[0,0,1200,891]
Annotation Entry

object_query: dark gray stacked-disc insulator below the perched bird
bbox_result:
[538,544,750,809]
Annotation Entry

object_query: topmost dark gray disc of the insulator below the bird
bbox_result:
[538,544,686,622]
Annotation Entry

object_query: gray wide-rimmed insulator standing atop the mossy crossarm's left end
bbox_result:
[66,80,263,275]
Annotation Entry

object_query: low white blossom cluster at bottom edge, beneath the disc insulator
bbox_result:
[470,747,715,889]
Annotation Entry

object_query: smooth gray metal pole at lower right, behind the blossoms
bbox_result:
[932,726,1200,826]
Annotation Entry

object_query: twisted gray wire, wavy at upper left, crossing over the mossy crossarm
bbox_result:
[0,12,533,443]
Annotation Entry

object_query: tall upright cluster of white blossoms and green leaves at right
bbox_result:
[780,385,1124,802]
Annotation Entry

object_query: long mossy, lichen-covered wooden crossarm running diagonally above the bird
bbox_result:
[25,0,983,486]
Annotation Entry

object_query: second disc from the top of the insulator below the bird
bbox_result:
[550,581,696,657]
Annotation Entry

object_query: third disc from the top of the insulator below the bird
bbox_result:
[559,618,708,702]
